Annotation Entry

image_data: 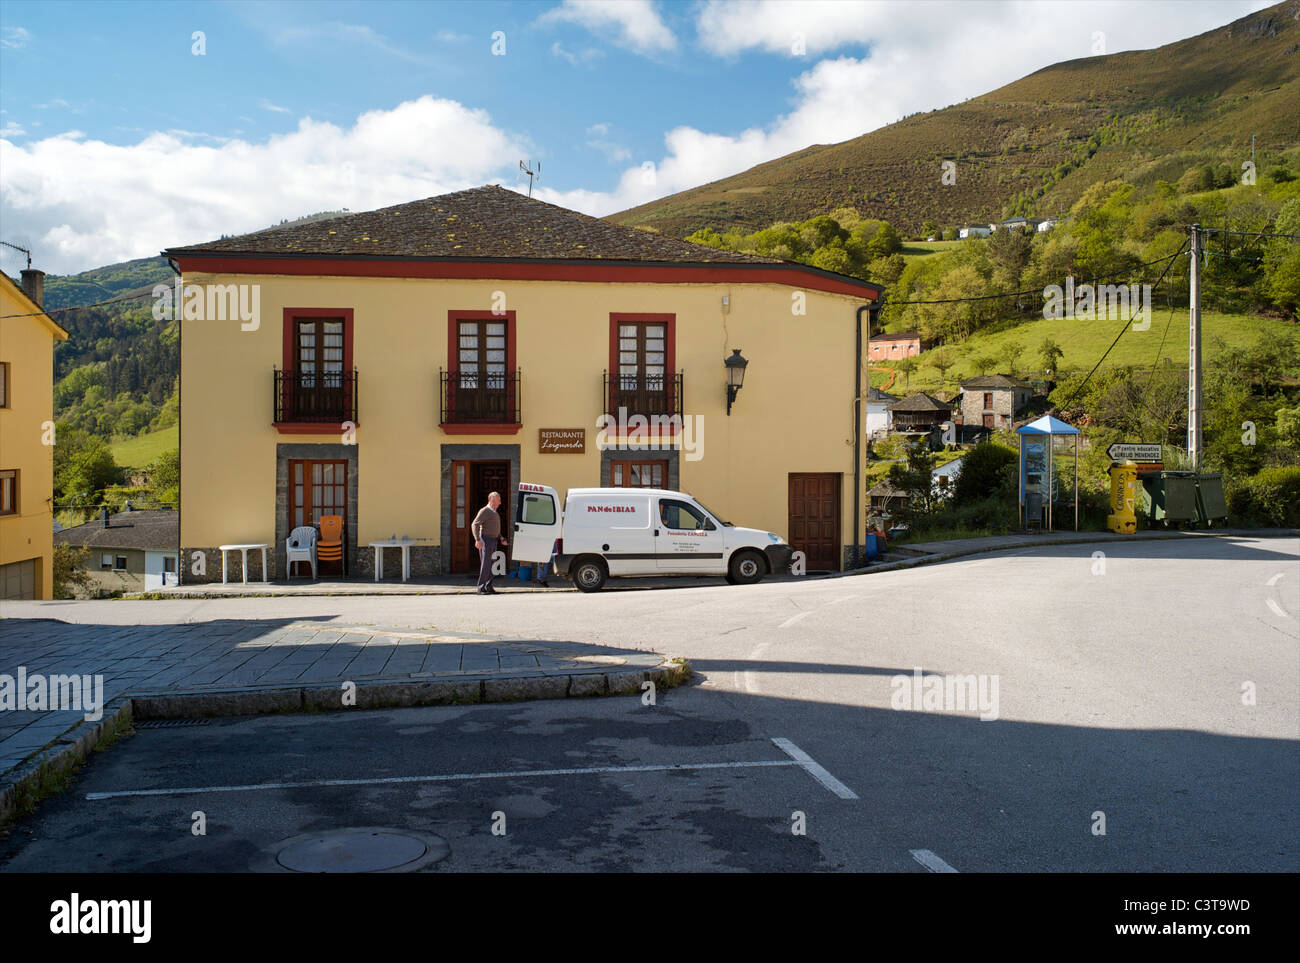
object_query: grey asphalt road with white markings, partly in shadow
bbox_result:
[0,538,1300,872]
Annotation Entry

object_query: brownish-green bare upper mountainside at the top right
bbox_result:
[608,0,1300,238]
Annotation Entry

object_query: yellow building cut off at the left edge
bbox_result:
[0,269,68,599]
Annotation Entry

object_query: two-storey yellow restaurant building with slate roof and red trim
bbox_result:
[165,187,880,582]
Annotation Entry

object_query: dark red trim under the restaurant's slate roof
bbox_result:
[176,255,883,300]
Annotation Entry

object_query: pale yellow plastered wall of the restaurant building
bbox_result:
[181,274,866,571]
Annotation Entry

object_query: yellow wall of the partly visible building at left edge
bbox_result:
[0,278,56,599]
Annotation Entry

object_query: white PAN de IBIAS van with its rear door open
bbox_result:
[514,483,793,591]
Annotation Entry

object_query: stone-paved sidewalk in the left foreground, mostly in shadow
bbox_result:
[0,616,663,784]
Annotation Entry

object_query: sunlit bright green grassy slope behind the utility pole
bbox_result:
[872,308,1300,395]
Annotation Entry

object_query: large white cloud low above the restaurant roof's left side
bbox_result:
[0,96,532,274]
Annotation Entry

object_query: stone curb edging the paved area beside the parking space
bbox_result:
[0,660,692,827]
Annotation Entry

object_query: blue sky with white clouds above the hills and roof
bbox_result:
[0,0,1268,273]
